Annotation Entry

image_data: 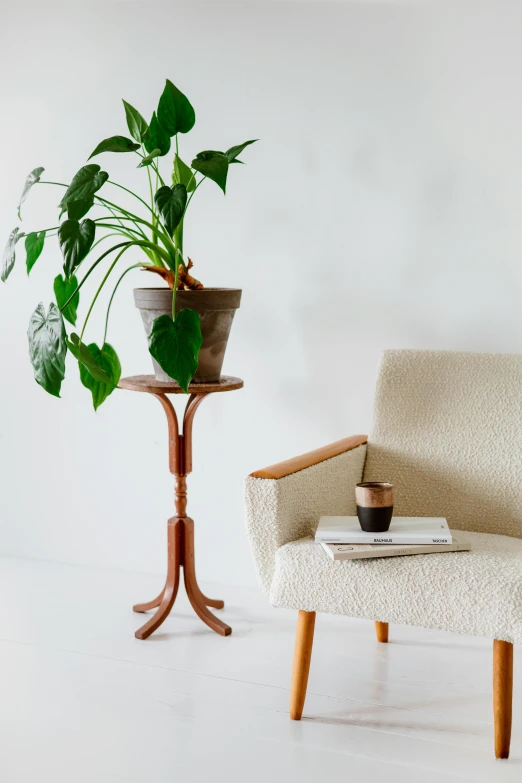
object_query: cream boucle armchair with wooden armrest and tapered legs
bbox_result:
[246,351,522,758]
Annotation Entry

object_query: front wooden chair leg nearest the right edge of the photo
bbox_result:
[493,639,513,759]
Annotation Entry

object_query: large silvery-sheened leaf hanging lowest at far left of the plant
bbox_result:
[27,302,67,397]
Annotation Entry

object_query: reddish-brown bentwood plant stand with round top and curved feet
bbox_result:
[119,375,243,639]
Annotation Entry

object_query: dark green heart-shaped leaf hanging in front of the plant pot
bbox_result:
[149,310,203,392]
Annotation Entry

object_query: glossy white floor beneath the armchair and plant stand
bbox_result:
[0,558,522,783]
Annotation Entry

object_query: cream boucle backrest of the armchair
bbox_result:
[364,351,522,538]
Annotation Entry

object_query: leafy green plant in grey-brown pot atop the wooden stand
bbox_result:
[1,79,256,409]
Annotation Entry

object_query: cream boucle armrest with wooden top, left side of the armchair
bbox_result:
[245,435,367,593]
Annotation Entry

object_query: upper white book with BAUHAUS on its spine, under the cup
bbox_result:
[315,517,452,544]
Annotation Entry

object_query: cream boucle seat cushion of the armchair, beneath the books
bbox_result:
[270,530,522,643]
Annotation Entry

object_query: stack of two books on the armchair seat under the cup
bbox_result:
[315,517,469,560]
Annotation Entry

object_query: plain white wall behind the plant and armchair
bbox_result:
[0,2,522,583]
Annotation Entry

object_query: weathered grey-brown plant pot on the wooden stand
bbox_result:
[134,288,241,383]
